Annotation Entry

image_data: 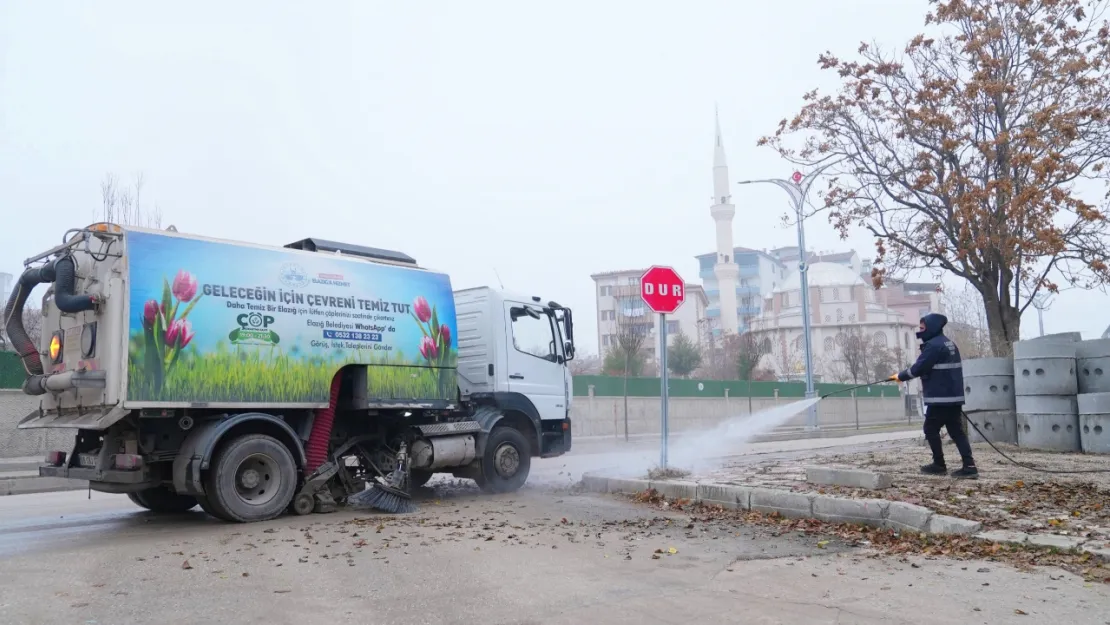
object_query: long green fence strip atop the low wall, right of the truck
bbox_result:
[574,375,900,399]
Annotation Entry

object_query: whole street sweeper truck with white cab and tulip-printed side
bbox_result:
[3,223,574,522]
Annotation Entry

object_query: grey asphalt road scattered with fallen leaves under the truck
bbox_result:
[0,439,1110,625]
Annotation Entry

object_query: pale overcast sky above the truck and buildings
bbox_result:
[0,0,1110,352]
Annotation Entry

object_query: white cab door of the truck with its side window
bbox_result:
[505,302,566,420]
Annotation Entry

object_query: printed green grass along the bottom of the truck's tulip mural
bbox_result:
[128,343,456,403]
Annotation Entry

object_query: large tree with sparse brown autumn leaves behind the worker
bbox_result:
[761,0,1110,356]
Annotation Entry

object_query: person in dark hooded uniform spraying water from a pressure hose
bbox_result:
[890,313,979,480]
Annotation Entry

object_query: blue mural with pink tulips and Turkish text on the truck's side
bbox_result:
[128,232,458,404]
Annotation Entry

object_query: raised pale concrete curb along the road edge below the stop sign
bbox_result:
[582,473,991,540]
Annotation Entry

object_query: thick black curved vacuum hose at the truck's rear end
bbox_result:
[3,255,97,395]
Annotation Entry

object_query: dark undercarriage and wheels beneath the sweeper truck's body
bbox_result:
[40,395,571,522]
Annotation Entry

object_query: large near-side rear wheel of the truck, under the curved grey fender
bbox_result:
[204,434,296,523]
